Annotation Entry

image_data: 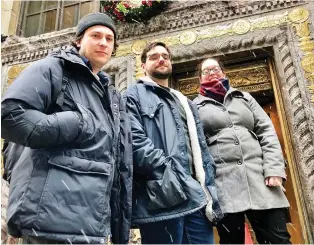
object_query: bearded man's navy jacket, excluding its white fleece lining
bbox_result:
[126,78,222,224]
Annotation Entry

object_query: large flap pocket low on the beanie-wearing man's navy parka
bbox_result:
[35,156,113,236]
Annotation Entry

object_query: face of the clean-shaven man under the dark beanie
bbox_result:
[77,25,114,73]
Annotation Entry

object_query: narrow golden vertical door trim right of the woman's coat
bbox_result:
[267,59,311,244]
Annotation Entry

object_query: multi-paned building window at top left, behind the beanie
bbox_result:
[19,0,94,37]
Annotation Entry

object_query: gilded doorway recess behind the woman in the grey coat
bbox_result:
[172,49,304,244]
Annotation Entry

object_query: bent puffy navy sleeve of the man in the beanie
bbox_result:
[1,57,81,148]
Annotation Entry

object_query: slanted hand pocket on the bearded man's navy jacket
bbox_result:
[146,164,188,210]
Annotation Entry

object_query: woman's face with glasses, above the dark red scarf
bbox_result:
[200,59,225,81]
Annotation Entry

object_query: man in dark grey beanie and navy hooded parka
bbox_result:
[1,13,132,244]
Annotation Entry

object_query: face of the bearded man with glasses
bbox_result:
[142,46,172,80]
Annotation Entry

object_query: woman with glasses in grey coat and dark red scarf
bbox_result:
[194,59,290,244]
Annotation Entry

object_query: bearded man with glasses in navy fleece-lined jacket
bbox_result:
[126,42,222,244]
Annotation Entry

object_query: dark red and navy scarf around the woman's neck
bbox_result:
[200,78,230,103]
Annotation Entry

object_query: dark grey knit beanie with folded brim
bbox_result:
[75,13,117,39]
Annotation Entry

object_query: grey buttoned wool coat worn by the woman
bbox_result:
[194,88,289,213]
